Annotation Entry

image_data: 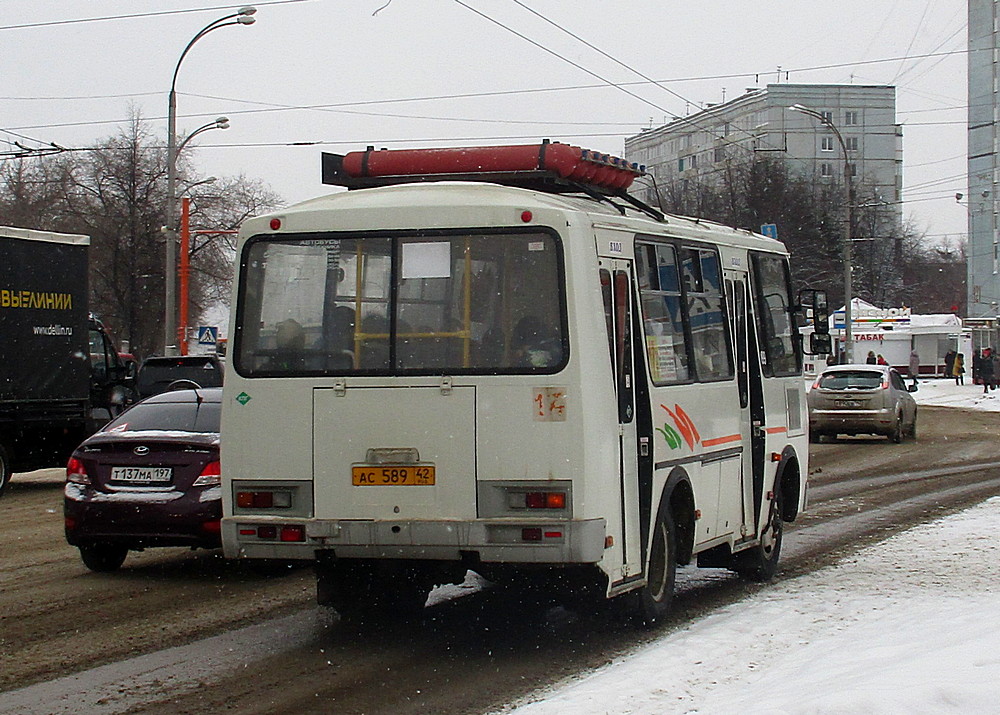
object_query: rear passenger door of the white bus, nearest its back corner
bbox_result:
[600,259,653,578]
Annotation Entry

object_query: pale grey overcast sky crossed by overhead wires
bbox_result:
[0,0,967,242]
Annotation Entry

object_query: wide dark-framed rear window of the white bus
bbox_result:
[234,230,568,377]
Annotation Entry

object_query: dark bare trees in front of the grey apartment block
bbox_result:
[657,155,965,312]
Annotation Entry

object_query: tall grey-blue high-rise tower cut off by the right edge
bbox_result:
[967,0,1000,322]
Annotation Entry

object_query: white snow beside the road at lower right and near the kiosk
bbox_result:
[503,380,1000,715]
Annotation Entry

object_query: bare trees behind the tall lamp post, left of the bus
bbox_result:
[0,113,281,356]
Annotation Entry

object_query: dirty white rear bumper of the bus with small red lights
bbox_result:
[222,516,606,564]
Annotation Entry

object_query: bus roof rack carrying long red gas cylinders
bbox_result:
[322,140,664,221]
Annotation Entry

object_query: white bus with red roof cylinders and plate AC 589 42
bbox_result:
[222,144,828,623]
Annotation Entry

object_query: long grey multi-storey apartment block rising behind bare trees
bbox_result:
[625,84,903,223]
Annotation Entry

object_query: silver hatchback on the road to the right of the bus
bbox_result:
[808,365,917,443]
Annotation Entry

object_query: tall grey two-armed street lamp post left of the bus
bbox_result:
[163,7,257,355]
